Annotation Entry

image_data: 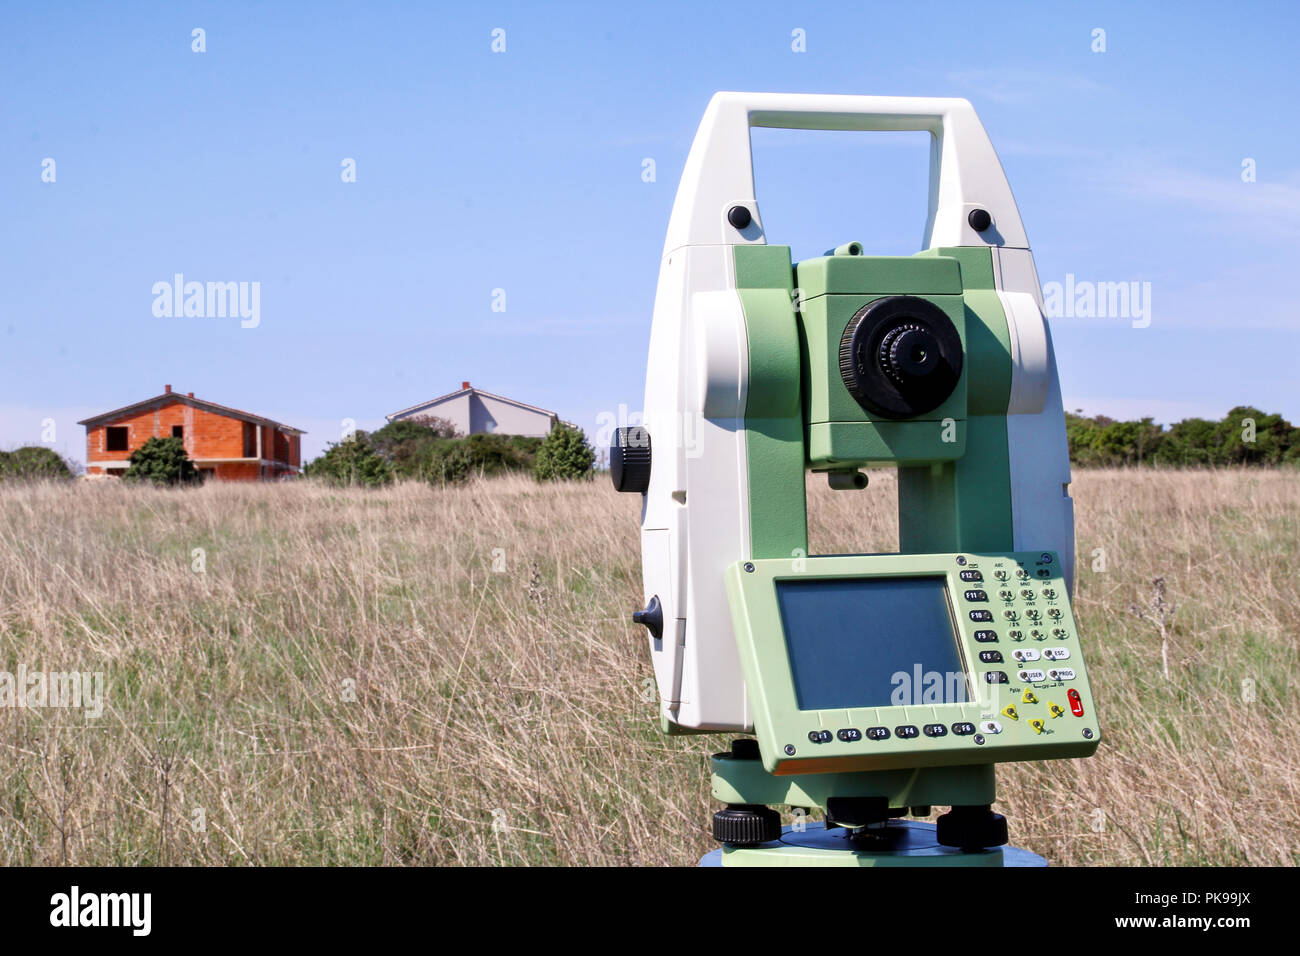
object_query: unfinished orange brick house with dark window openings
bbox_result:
[77,385,304,481]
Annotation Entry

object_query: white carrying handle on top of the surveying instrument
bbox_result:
[664,92,1028,255]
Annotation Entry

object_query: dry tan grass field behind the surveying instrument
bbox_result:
[0,471,1300,865]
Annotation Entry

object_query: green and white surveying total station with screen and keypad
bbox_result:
[610,92,1101,866]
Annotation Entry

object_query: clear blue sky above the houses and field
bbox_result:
[0,3,1300,460]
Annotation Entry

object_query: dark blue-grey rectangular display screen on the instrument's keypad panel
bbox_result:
[776,578,969,710]
